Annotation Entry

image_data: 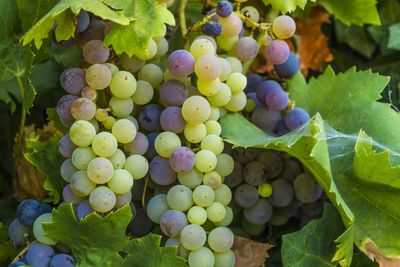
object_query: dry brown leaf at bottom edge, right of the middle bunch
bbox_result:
[232,236,273,267]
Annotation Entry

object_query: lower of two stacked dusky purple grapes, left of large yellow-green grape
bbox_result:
[160,107,186,133]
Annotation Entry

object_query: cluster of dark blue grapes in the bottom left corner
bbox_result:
[8,199,75,267]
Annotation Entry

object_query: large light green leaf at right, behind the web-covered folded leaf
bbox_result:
[288,67,400,154]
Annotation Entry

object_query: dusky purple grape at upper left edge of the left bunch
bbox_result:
[60,68,86,95]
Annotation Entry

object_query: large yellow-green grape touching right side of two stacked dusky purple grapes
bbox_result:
[182,95,211,124]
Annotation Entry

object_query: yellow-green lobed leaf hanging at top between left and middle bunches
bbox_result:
[104,0,175,56]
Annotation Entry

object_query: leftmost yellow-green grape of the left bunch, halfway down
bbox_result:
[69,120,96,147]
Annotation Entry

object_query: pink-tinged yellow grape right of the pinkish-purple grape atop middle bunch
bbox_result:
[194,55,222,81]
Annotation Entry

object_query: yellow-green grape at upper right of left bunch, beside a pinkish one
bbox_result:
[110,71,137,98]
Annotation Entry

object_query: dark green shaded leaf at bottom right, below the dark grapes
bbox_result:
[281,204,344,267]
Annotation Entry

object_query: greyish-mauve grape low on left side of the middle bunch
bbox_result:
[160,210,188,237]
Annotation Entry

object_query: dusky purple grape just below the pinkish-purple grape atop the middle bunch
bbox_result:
[160,80,189,106]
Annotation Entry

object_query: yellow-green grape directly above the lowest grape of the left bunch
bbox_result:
[87,157,114,184]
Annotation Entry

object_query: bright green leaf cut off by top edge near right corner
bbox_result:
[318,0,381,25]
